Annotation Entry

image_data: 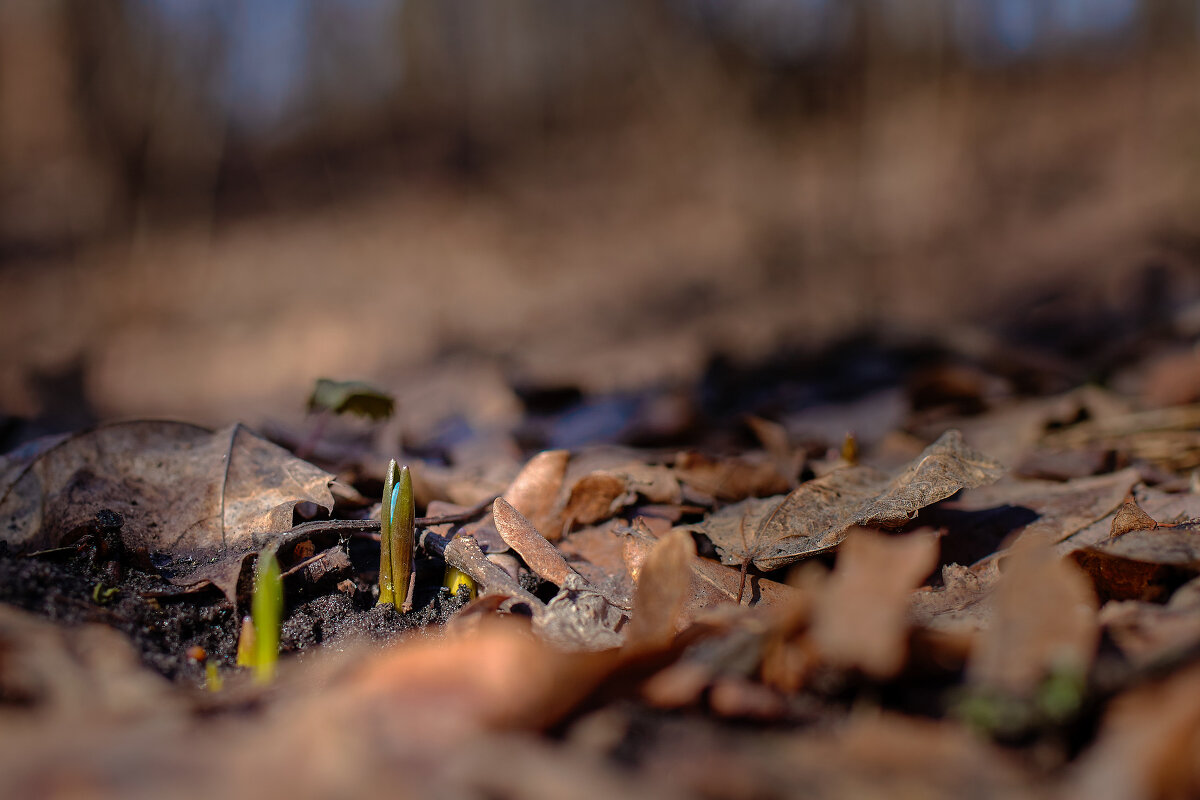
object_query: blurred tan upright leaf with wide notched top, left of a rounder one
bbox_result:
[812,529,937,678]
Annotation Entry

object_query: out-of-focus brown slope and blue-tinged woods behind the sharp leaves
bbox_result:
[0,0,1200,446]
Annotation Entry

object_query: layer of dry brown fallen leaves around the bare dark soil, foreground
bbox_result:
[11,386,1200,799]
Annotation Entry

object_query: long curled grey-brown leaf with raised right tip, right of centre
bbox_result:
[690,431,1003,571]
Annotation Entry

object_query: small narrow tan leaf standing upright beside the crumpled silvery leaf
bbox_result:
[626,530,696,649]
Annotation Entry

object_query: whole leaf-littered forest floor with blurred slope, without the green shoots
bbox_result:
[0,54,1200,798]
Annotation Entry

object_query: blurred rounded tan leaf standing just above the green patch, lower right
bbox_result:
[967,543,1099,697]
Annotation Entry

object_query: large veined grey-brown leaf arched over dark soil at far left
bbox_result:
[0,421,334,599]
